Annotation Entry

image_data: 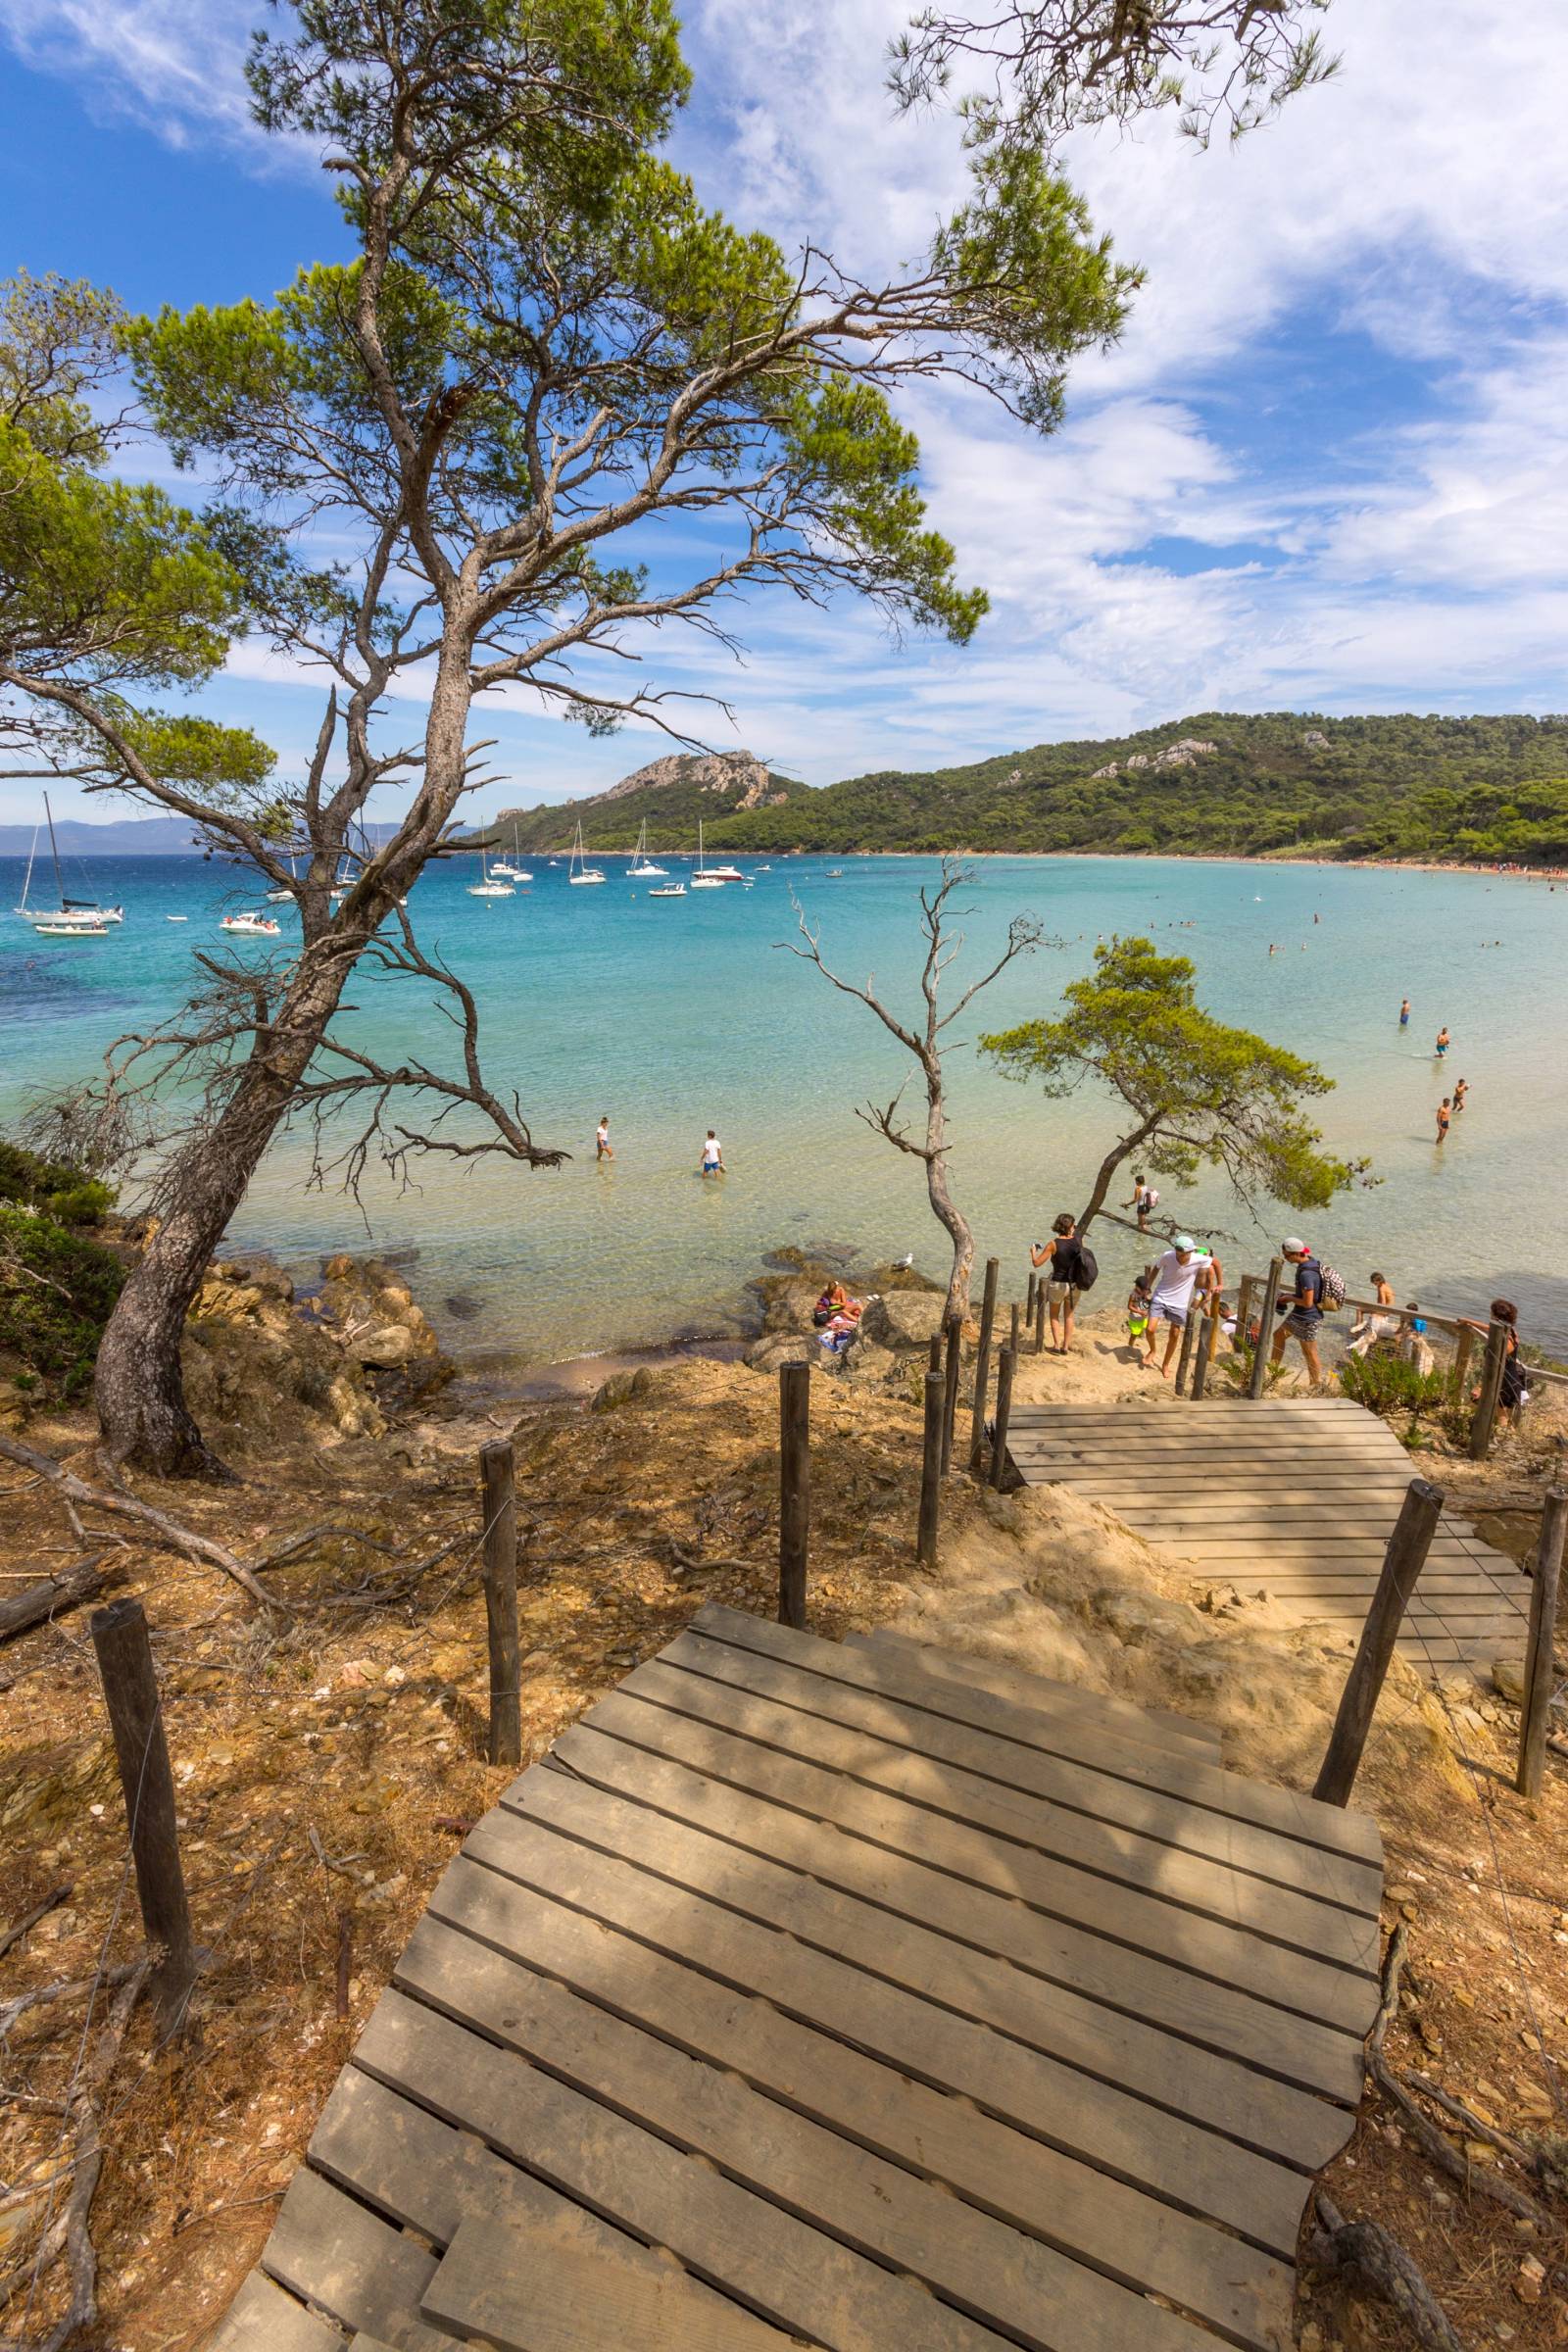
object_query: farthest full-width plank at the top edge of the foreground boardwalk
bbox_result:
[696,1604,1382,1872]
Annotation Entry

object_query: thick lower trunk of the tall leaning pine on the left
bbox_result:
[94,941,353,1480]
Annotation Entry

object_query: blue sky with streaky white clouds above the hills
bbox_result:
[0,0,1568,818]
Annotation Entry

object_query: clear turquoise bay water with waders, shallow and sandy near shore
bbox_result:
[0,858,1568,1359]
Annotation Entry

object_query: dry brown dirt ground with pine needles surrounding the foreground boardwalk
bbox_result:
[0,1289,1568,2352]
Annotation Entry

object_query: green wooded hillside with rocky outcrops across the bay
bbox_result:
[491,710,1568,865]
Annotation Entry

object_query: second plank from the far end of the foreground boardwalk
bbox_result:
[661,1633,1380,1919]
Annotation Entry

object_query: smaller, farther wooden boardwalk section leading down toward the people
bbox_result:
[1008,1397,1531,1670]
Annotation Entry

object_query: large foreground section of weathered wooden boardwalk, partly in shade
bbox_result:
[214,1606,1382,2352]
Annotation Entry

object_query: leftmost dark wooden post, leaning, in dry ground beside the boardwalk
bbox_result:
[89,1599,195,2041]
